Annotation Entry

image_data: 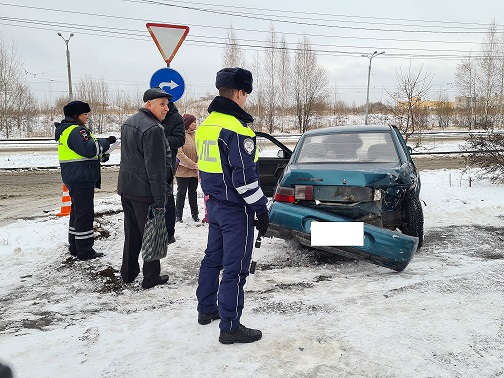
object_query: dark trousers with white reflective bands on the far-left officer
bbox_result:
[68,188,95,259]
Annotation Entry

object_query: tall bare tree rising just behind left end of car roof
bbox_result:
[293,36,328,133]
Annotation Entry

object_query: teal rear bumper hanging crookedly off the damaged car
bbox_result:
[266,202,418,272]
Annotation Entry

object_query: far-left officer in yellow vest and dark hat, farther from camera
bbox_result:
[54,101,116,260]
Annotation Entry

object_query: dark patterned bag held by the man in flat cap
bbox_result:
[141,205,168,262]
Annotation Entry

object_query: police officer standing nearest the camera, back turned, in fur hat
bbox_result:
[196,68,269,344]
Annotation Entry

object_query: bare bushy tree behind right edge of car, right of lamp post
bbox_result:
[389,65,432,141]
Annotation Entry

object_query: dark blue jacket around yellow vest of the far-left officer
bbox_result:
[54,118,110,190]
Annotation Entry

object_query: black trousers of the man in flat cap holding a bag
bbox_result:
[121,196,161,285]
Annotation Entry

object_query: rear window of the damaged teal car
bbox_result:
[297,132,399,164]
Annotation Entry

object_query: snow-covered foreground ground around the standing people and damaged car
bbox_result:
[0,153,504,378]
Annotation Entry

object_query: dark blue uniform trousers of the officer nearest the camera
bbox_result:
[196,197,254,331]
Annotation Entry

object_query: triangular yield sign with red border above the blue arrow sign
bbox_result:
[146,23,189,64]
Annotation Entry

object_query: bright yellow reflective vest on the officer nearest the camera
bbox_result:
[196,112,258,173]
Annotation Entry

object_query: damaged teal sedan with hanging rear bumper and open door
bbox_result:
[259,125,423,271]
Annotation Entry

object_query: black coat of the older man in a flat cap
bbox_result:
[117,108,171,208]
